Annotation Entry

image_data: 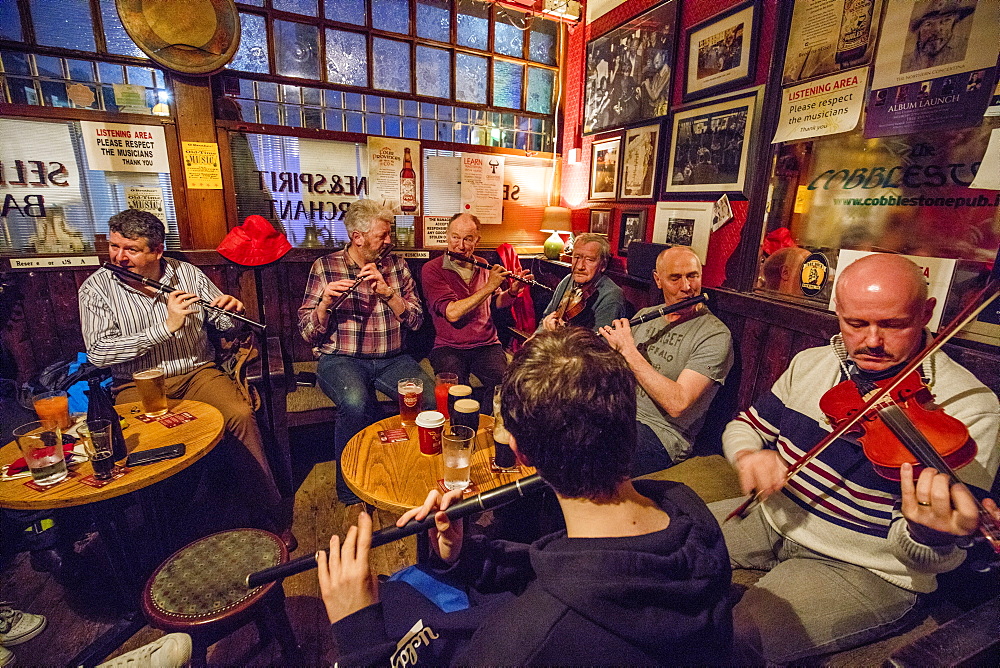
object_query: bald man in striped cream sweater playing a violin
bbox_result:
[710,254,1000,665]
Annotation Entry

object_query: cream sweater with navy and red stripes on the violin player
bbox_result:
[722,337,1000,593]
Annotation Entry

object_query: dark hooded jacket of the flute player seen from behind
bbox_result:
[333,481,732,666]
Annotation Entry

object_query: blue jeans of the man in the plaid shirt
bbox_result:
[316,354,434,503]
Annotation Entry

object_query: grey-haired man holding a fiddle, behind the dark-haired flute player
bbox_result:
[538,234,625,332]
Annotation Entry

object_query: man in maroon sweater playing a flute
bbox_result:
[421,213,532,403]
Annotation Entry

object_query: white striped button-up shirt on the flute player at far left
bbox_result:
[80,258,235,381]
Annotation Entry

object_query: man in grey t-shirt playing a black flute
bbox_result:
[600,246,733,475]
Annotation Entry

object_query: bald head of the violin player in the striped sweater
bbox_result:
[837,253,936,371]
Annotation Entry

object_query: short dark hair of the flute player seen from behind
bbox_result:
[502,327,636,500]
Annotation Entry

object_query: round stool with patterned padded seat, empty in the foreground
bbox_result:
[142,529,301,665]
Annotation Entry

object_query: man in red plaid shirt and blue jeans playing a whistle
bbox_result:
[299,200,434,504]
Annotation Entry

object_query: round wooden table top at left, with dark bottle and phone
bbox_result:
[0,399,225,510]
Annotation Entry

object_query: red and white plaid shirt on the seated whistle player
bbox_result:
[299,250,424,359]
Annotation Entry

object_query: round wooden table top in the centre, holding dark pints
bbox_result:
[340,415,535,514]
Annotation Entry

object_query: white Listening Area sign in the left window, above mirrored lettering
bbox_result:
[80,121,168,172]
